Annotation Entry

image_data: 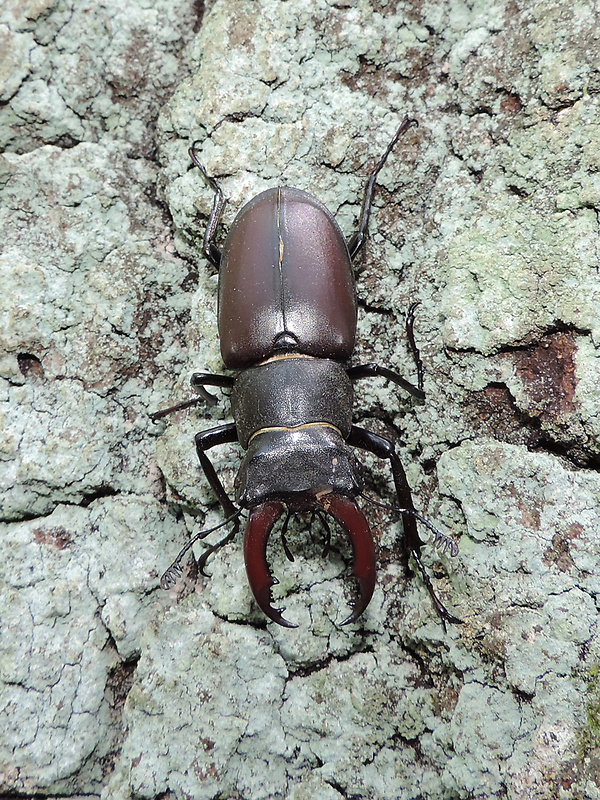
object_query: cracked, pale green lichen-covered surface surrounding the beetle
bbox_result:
[0,0,600,800]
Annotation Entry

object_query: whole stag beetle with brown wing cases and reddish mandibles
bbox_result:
[152,119,460,627]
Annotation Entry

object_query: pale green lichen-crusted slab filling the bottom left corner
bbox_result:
[0,496,181,794]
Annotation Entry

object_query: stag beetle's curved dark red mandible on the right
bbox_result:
[318,494,376,625]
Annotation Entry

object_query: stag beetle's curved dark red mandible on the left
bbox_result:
[244,501,297,628]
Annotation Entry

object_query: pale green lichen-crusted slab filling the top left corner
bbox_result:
[0,0,196,154]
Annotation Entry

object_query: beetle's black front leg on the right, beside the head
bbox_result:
[348,425,462,624]
